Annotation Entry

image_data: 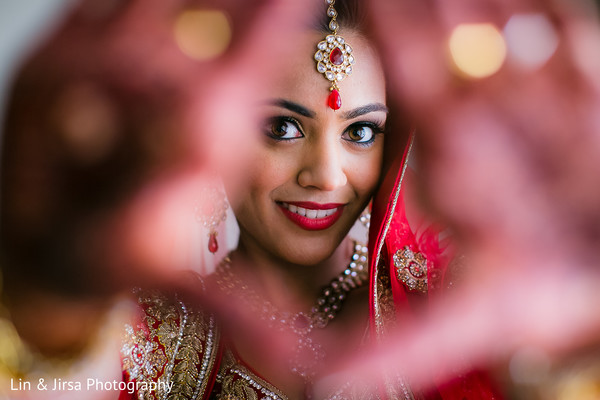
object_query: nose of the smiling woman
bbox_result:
[298,138,348,191]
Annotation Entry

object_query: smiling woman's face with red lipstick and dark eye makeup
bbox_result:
[227,32,387,265]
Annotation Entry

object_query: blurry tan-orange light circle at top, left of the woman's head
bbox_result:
[173,10,231,61]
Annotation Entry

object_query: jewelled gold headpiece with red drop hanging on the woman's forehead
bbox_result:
[315,0,354,110]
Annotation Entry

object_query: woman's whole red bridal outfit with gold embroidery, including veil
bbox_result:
[120,133,501,400]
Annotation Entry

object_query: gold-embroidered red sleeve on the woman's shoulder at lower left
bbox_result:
[121,293,218,400]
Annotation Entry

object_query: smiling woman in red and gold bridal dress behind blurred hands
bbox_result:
[122,0,498,399]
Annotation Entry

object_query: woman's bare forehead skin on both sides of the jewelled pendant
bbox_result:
[267,31,385,112]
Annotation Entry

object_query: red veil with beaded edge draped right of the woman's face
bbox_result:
[369,131,502,400]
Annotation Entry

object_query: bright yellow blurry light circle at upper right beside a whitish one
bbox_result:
[449,23,506,78]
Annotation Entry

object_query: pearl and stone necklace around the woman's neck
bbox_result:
[215,242,368,382]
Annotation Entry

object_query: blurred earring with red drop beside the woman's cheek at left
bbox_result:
[195,187,229,253]
